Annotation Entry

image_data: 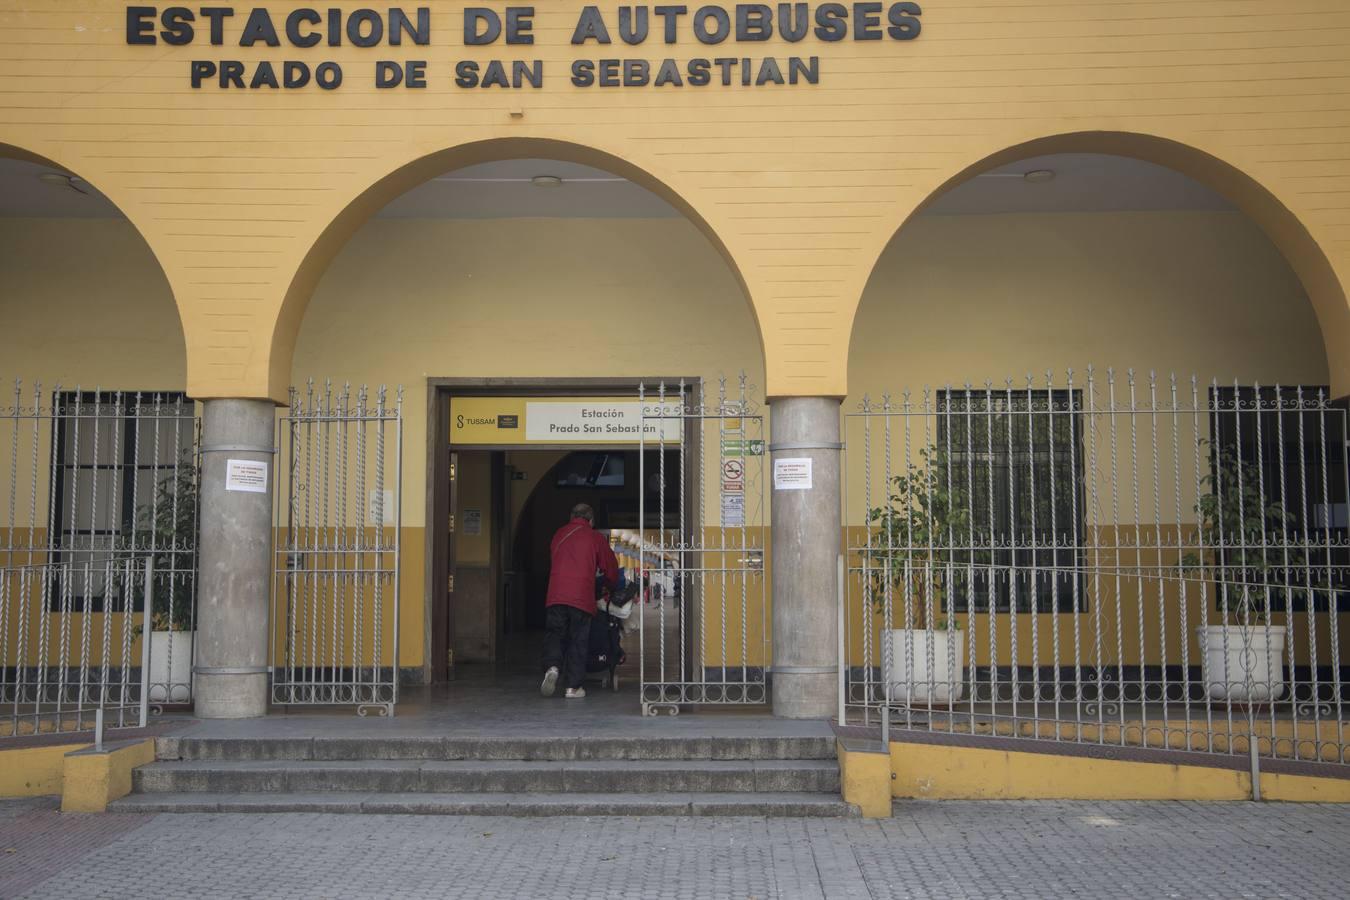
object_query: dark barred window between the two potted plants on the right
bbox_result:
[937,389,1087,613]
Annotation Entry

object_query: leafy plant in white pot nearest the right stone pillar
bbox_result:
[863,448,973,706]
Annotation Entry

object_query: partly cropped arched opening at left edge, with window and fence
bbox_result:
[0,144,198,734]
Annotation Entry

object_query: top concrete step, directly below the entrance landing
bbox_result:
[157,735,834,761]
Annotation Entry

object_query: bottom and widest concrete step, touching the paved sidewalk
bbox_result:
[108,792,857,818]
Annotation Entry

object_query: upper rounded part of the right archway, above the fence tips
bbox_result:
[849,132,1350,395]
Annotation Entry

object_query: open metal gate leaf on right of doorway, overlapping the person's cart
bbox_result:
[630,374,770,715]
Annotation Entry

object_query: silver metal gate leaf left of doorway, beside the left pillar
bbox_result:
[271,382,404,715]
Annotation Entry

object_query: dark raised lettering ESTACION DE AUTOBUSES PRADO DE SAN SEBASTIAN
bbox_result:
[127,3,922,90]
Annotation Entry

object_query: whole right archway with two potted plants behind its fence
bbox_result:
[844,134,1350,769]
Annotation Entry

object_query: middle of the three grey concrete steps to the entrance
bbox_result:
[132,760,840,793]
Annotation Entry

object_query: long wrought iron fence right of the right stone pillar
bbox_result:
[841,368,1350,765]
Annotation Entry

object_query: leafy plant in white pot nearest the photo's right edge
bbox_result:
[1181,448,1301,703]
